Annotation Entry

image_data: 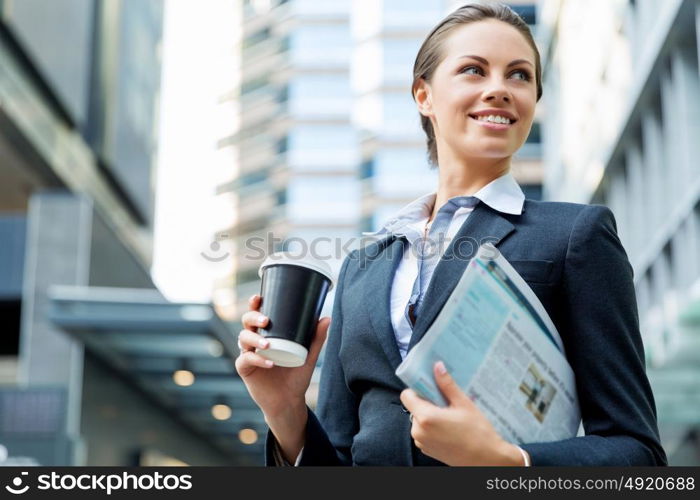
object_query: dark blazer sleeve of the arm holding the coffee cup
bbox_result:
[265,251,359,466]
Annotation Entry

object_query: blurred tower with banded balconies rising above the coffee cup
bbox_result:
[219,0,359,317]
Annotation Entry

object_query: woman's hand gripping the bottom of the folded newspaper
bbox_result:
[401,361,524,465]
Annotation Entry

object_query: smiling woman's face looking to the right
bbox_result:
[415,19,537,163]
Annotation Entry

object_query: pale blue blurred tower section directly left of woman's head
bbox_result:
[352,0,449,231]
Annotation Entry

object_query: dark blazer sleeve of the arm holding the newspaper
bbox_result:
[521,205,667,466]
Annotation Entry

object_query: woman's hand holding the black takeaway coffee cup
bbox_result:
[236,295,330,419]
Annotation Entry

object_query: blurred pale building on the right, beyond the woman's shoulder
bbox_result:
[539,0,700,465]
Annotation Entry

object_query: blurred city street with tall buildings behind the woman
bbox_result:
[0,0,700,466]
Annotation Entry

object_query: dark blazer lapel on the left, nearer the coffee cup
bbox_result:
[362,236,408,369]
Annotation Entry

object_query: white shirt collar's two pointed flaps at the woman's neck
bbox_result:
[362,172,525,236]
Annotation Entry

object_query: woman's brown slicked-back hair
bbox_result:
[411,4,542,168]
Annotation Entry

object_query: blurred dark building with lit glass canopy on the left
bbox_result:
[0,0,263,465]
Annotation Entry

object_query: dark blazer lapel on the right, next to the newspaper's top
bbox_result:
[408,203,514,351]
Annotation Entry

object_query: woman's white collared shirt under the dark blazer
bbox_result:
[362,172,525,359]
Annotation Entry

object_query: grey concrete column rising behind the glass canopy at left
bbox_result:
[18,191,93,463]
